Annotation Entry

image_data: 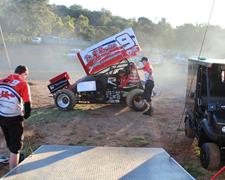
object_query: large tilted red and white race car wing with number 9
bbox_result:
[77,28,140,75]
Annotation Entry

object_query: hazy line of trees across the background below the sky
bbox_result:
[0,0,225,55]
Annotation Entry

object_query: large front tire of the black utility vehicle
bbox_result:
[200,143,221,170]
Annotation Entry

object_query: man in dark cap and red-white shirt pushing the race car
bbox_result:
[138,57,154,116]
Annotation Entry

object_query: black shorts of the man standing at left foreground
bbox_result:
[0,116,23,154]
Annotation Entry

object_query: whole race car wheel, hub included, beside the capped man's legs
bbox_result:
[126,89,147,111]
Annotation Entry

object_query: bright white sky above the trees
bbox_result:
[49,0,225,28]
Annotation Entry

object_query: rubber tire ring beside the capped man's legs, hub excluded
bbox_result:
[126,89,146,111]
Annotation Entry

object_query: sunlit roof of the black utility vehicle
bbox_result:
[188,56,225,67]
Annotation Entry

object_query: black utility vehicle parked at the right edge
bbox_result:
[184,57,225,170]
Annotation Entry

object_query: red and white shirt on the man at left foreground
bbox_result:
[0,74,31,117]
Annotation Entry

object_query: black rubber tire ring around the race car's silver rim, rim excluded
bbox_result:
[55,89,77,111]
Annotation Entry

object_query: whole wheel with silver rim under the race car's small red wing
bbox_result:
[54,89,77,111]
